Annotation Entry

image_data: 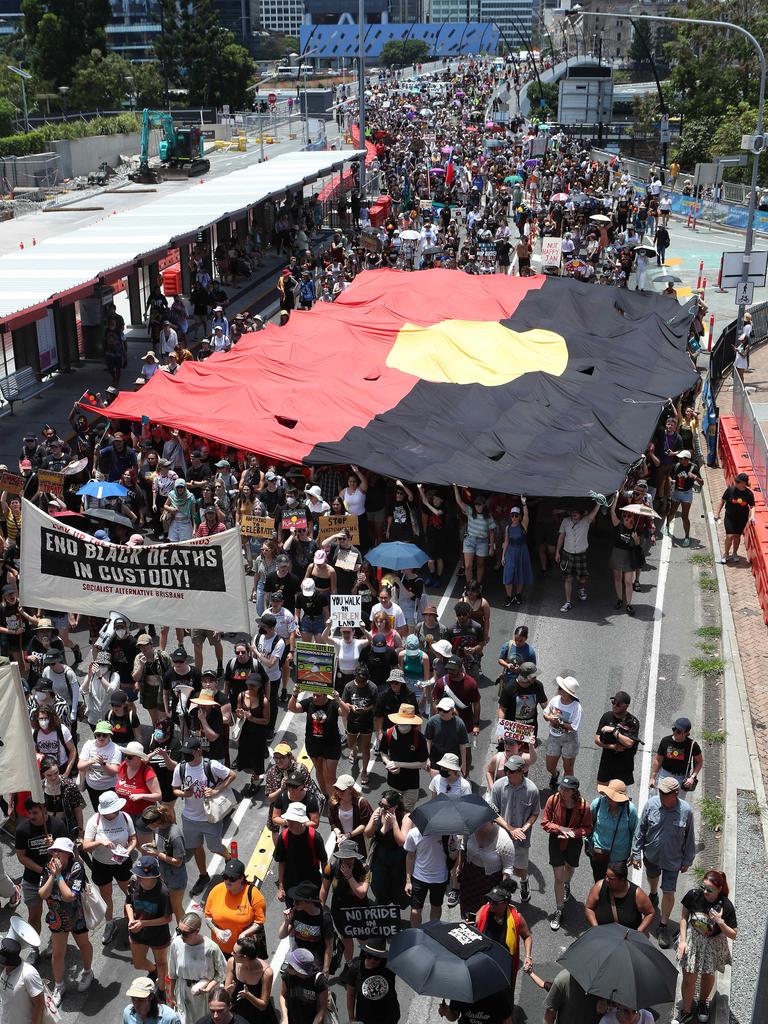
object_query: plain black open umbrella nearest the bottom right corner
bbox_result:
[557,925,678,1010]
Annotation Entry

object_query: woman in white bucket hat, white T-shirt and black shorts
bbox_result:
[83,790,136,945]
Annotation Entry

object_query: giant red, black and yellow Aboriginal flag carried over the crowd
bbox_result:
[105,270,696,496]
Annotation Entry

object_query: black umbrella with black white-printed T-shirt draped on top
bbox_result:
[387,921,512,1002]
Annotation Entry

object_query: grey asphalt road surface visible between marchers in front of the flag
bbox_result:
[0,497,720,1024]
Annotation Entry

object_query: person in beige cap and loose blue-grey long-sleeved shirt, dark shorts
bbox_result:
[632,775,696,949]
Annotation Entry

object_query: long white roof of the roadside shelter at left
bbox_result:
[0,150,361,322]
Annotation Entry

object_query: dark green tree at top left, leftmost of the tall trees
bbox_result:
[22,0,112,87]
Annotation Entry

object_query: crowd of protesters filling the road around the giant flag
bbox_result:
[0,54,751,1024]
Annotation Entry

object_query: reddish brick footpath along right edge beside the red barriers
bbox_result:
[703,364,768,790]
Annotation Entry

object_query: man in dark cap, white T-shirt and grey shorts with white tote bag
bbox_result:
[172,736,234,896]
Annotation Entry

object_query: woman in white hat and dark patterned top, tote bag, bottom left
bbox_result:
[39,839,93,1006]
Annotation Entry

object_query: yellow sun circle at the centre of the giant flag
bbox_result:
[386,319,568,387]
